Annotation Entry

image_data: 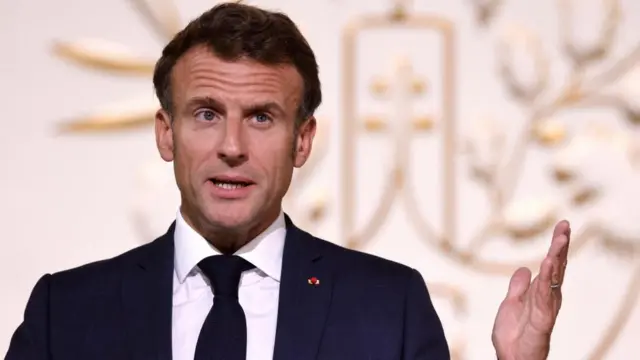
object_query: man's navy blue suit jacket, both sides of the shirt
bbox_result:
[5,217,450,360]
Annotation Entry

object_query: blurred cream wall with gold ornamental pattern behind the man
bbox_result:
[0,0,640,360]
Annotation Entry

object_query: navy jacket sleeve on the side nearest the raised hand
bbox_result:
[402,269,451,360]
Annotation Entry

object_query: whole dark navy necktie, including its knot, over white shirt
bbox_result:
[195,255,254,360]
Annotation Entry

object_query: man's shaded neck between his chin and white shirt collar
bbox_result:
[180,206,280,255]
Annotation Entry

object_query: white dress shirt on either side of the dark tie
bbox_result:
[172,211,286,360]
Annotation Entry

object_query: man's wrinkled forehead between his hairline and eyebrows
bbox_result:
[172,47,303,107]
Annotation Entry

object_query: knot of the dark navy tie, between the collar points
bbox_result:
[198,255,255,298]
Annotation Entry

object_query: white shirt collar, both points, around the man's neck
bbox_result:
[174,210,287,283]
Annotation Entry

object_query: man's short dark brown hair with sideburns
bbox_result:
[153,3,322,124]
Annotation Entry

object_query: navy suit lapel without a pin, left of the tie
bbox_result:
[122,223,175,360]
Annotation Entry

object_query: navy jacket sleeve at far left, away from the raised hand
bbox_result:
[5,274,51,360]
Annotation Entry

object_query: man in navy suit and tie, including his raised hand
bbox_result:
[6,3,569,360]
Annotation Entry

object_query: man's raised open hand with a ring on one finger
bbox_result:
[491,221,571,360]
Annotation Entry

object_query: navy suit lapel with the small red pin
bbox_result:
[274,216,333,360]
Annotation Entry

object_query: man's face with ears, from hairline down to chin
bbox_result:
[155,47,315,236]
